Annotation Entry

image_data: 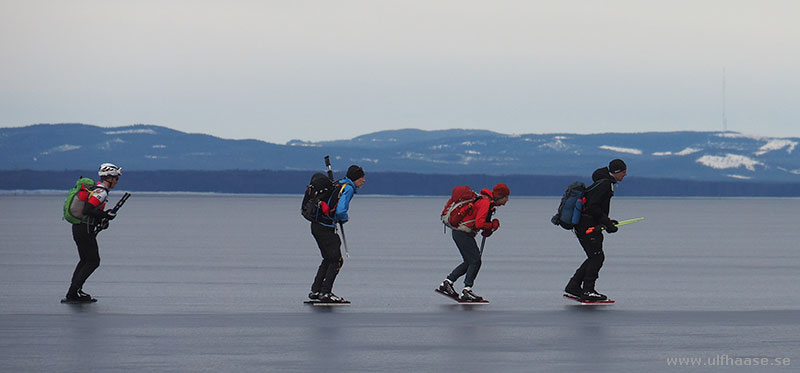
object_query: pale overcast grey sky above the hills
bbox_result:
[0,0,800,143]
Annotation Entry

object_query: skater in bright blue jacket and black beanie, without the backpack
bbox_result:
[308,165,366,303]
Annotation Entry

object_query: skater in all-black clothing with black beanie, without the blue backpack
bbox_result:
[564,159,628,301]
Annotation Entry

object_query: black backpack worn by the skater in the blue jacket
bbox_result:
[300,172,347,225]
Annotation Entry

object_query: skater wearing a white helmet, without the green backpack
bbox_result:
[66,163,122,302]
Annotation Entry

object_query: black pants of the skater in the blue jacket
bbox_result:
[311,223,344,293]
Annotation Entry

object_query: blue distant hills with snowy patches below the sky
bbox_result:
[0,124,800,183]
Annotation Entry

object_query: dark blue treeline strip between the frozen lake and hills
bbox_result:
[0,169,800,197]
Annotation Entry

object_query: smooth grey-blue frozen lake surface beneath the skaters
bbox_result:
[0,191,800,372]
